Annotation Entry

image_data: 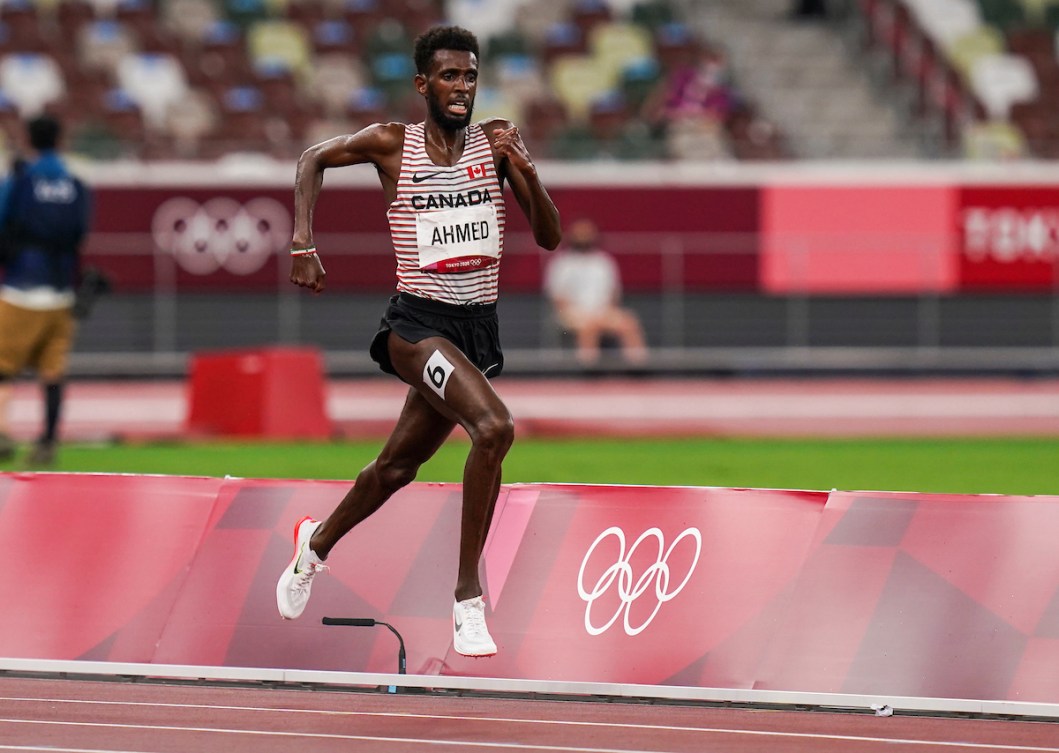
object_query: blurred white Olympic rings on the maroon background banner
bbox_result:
[150,196,292,274]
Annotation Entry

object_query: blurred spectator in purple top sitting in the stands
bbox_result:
[644,49,737,160]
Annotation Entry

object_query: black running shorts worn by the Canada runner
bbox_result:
[370,292,504,378]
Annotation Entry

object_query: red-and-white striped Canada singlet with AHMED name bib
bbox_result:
[387,123,505,304]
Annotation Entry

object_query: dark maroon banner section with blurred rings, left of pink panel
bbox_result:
[86,185,758,293]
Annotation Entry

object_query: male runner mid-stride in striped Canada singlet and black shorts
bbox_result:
[276,26,561,657]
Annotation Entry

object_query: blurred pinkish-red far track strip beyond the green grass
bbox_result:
[12,378,1059,441]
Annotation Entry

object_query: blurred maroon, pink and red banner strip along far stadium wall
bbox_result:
[78,168,1059,295]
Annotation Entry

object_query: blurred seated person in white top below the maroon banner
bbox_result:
[544,219,647,365]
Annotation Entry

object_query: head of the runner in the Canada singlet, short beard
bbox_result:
[415,26,479,130]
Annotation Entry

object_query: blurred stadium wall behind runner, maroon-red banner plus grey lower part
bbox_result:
[74,163,1059,373]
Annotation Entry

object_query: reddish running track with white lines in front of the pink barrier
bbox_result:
[0,677,1059,753]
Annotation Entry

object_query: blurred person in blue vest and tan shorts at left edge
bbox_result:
[0,115,90,467]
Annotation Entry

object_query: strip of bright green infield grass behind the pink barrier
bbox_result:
[10,435,1059,495]
